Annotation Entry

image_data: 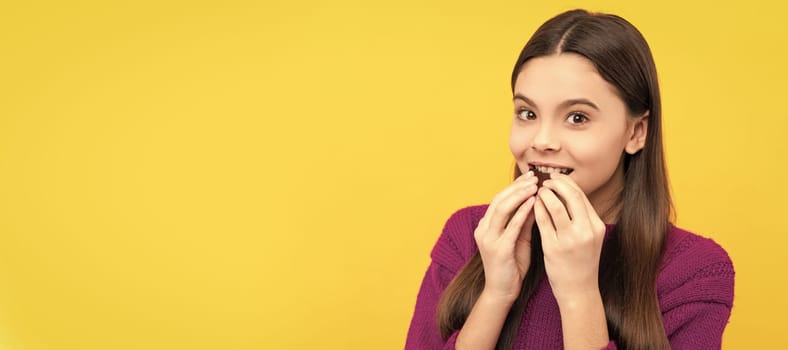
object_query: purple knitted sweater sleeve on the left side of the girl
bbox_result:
[405,207,484,350]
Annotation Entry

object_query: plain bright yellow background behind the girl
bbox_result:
[0,0,788,350]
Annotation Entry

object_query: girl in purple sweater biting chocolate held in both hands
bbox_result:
[405,10,734,349]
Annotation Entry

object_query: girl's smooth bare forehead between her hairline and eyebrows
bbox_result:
[514,53,623,105]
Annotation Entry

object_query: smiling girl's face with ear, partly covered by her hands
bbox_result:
[509,53,647,215]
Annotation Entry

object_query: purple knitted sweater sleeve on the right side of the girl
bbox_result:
[661,232,734,350]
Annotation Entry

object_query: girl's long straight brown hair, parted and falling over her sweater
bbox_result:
[437,10,673,349]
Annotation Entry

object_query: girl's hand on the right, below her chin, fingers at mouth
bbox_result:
[534,174,605,305]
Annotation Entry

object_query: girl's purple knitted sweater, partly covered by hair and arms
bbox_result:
[405,205,734,350]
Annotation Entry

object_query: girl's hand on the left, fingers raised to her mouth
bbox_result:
[474,171,537,302]
